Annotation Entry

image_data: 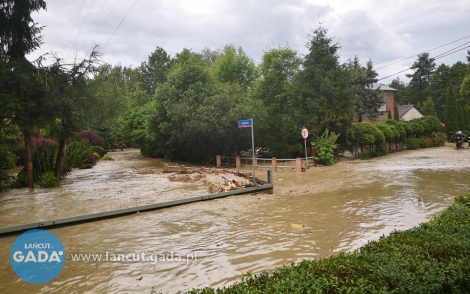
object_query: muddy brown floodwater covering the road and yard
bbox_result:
[0,145,470,293]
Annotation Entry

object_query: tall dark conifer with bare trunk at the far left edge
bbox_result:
[0,0,47,188]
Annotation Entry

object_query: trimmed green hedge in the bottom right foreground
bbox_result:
[177,193,470,294]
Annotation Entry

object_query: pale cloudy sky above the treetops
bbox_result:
[30,0,470,84]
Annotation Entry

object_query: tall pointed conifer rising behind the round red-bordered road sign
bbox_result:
[298,26,356,134]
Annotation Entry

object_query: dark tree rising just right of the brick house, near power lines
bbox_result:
[406,53,436,104]
